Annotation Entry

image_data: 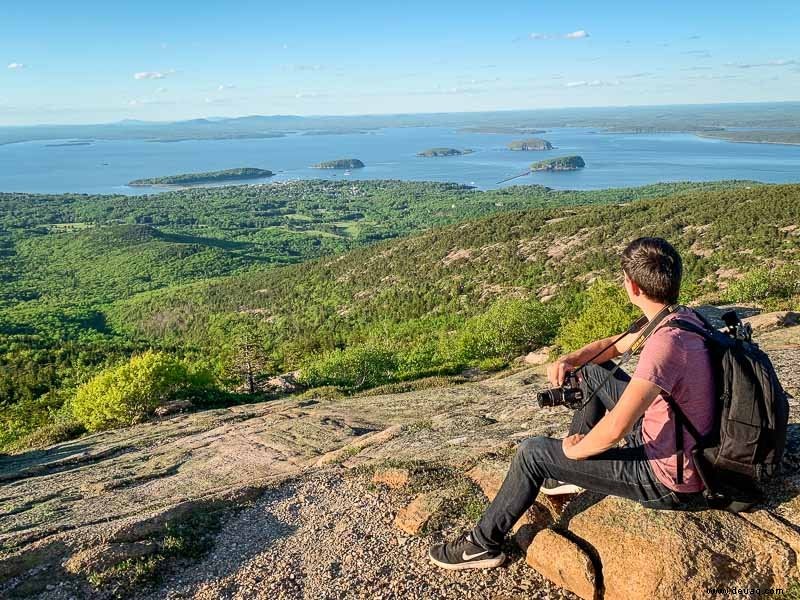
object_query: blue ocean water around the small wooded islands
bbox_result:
[0,127,800,194]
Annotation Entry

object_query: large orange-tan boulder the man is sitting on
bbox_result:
[564,497,797,600]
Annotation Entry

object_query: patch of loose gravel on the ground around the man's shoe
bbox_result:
[153,469,574,600]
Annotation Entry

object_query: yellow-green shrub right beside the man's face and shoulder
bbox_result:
[556,280,641,352]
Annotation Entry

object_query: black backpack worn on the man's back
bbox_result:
[664,312,789,512]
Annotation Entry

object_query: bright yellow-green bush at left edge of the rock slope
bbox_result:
[71,351,211,431]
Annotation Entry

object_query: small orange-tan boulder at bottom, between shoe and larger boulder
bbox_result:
[525,529,597,600]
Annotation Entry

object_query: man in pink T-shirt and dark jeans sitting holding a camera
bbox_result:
[430,238,714,569]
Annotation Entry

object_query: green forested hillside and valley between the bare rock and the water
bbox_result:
[0,181,800,451]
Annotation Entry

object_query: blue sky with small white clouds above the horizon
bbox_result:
[0,0,800,125]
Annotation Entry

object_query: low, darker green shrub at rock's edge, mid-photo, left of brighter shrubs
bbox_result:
[300,345,397,390]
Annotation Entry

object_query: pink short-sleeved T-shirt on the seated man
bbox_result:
[633,309,714,492]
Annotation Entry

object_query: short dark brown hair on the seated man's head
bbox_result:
[622,237,683,304]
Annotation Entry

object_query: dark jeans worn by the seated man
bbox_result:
[472,363,685,550]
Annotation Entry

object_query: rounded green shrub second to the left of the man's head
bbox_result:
[456,300,560,360]
